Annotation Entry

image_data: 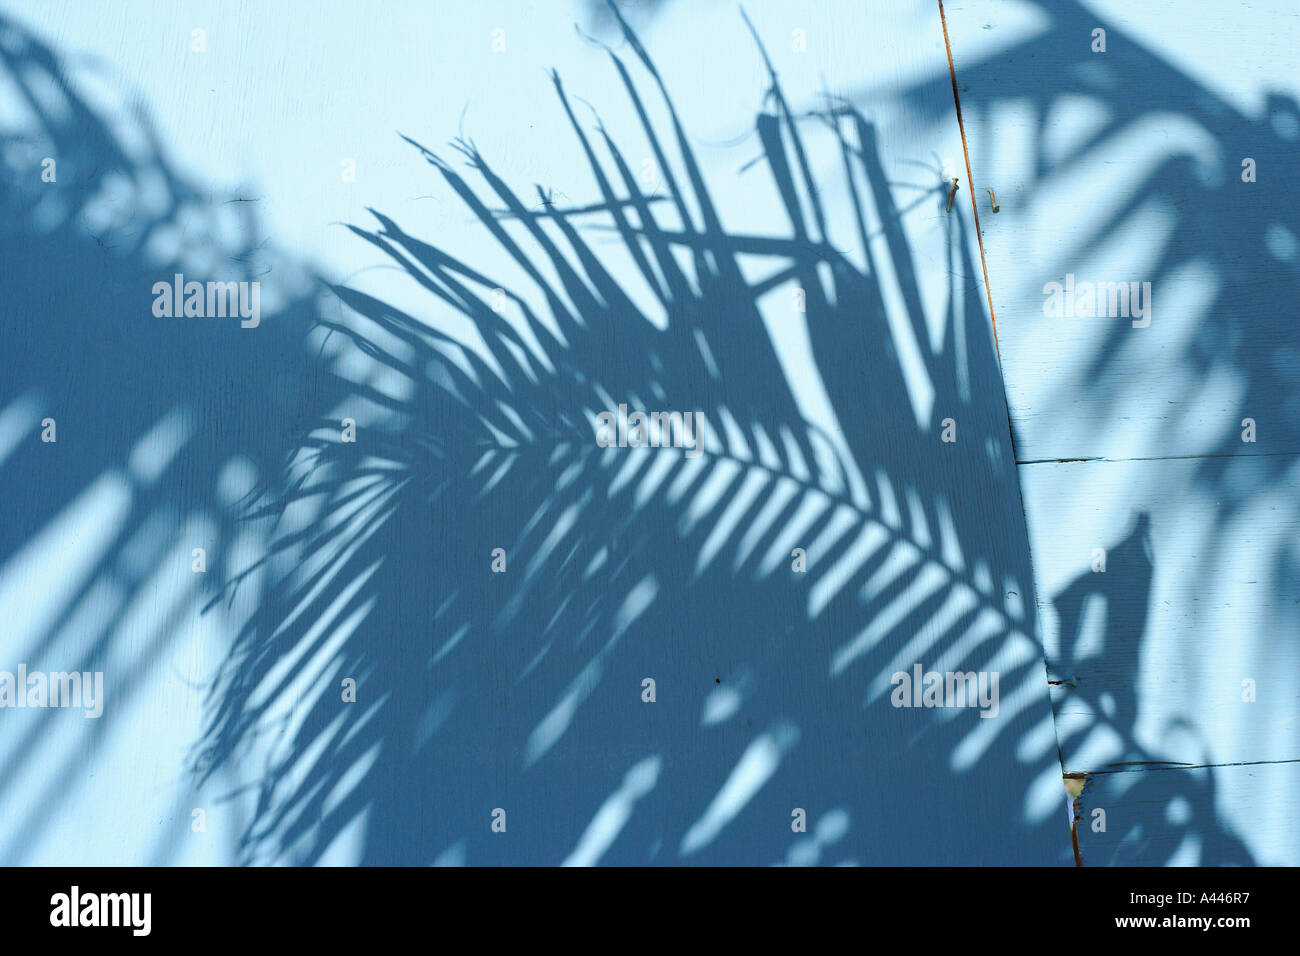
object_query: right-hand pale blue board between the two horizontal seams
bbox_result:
[1021,458,1300,771]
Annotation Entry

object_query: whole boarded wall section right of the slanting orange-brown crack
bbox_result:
[945,0,1300,865]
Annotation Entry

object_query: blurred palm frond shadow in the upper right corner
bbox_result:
[906,0,1300,476]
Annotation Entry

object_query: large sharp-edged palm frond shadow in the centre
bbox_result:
[198,11,1069,864]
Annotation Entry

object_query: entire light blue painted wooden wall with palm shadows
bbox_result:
[0,0,1300,865]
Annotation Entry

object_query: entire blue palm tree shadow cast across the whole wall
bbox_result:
[0,5,1263,864]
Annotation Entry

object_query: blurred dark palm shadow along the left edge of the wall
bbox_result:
[0,17,340,864]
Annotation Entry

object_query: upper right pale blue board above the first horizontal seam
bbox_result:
[949,1,1300,462]
